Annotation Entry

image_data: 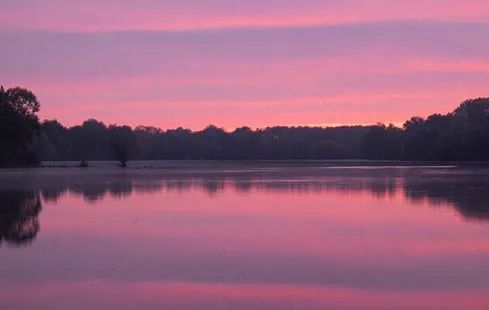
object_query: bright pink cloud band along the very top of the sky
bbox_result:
[0,0,489,31]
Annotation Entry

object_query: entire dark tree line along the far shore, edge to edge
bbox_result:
[0,87,489,167]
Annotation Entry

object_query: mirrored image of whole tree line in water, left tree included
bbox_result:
[0,175,489,245]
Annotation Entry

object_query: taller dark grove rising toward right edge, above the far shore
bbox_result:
[363,98,489,161]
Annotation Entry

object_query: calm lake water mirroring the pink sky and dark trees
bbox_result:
[0,162,489,309]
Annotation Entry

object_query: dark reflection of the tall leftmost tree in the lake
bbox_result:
[0,191,42,246]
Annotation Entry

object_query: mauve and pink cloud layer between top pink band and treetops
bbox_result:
[0,22,489,128]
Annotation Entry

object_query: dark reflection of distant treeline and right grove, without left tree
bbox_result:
[39,172,489,220]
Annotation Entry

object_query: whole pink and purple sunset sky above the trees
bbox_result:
[0,0,489,129]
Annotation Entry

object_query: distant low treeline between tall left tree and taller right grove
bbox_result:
[42,120,368,162]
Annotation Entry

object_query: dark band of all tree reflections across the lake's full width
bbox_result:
[0,168,489,245]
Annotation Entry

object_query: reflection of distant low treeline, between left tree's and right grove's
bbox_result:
[41,178,398,202]
